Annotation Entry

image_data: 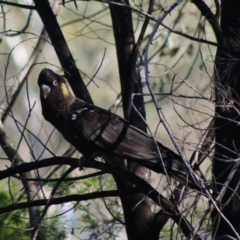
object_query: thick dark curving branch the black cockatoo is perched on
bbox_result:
[0,157,199,236]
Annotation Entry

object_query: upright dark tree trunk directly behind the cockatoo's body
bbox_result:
[110,1,156,240]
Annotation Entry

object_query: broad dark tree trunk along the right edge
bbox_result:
[212,0,240,239]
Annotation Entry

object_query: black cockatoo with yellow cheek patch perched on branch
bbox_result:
[38,69,203,189]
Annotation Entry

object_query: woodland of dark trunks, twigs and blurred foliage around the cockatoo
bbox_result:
[0,0,240,240]
